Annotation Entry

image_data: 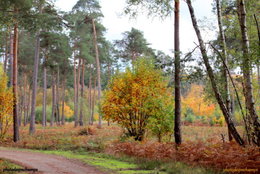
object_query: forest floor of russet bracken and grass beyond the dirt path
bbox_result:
[0,124,260,174]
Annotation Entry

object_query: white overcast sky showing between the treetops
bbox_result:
[56,0,216,54]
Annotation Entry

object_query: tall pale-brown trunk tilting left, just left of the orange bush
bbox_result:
[92,19,102,128]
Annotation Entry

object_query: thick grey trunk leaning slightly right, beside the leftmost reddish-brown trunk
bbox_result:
[29,31,40,134]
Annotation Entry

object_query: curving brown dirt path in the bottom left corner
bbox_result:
[0,148,105,174]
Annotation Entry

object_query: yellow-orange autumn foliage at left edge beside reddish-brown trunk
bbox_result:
[0,72,13,139]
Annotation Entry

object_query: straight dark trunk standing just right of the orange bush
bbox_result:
[174,0,182,145]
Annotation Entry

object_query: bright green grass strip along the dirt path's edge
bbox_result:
[16,150,217,174]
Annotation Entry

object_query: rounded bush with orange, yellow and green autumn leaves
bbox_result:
[101,59,173,140]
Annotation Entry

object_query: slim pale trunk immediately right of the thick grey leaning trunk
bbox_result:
[42,65,47,127]
